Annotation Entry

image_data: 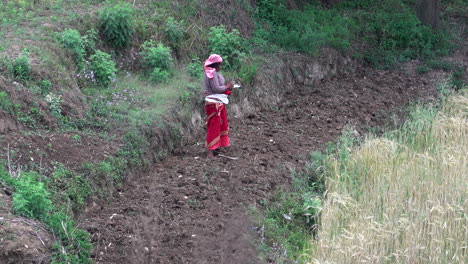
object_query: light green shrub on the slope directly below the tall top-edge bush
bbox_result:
[89,50,117,87]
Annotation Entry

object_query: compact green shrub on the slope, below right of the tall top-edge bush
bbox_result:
[140,40,174,71]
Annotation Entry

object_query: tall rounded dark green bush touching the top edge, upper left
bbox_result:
[99,3,134,48]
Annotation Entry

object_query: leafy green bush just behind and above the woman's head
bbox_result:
[208,25,246,68]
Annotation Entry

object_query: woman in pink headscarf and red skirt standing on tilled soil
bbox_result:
[203,54,234,159]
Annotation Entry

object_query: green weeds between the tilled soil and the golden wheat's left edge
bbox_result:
[251,157,324,263]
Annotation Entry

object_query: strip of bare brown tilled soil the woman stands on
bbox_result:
[82,71,436,264]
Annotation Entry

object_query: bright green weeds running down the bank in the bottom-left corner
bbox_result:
[0,166,92,263]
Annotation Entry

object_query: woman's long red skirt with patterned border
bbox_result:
[205,103,230,150]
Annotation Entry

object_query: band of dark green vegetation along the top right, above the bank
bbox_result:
[254,0,452,67]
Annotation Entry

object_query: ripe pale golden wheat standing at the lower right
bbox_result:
[311,94,468,263]
